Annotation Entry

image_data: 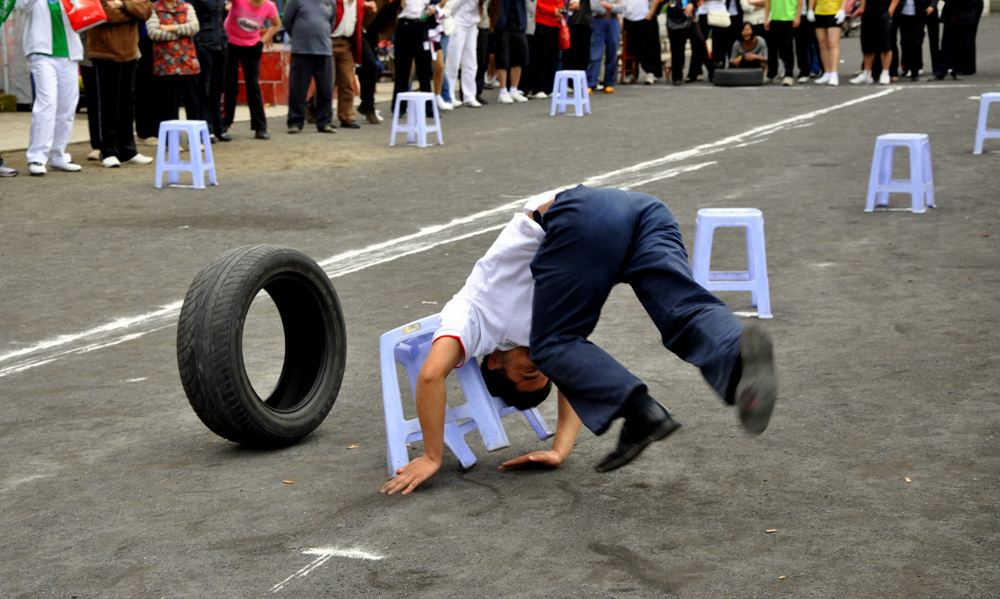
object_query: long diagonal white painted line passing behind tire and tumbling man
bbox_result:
[0,86,892,378]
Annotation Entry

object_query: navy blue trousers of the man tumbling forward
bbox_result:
[530,185,743,434]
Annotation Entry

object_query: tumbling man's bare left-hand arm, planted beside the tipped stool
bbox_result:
[381,337,462,495]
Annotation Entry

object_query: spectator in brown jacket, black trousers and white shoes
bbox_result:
[87,0,153,168]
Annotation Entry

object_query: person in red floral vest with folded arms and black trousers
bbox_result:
[146,0,201,121]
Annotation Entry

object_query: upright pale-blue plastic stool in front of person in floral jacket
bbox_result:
[156,121,219,189]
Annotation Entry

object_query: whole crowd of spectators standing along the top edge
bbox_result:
[0,0,983,177]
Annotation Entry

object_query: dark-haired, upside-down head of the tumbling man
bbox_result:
[479,347,552,410]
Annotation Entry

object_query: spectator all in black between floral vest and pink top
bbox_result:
[188,0,227,142]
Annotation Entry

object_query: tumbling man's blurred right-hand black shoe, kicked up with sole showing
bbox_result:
[735,325,778,435]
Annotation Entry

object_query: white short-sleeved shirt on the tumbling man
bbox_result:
[434,196,552,366]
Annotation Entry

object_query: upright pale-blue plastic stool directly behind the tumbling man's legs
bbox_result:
[692,208,771,318]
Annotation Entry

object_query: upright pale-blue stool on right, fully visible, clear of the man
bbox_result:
[865,133,934,214]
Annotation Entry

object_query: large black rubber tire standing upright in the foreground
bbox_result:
[177,245,347,448]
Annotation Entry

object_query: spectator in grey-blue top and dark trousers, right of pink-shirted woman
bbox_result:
[284,0,338,133]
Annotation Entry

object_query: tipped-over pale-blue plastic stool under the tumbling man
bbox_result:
[379,314,552,476]
